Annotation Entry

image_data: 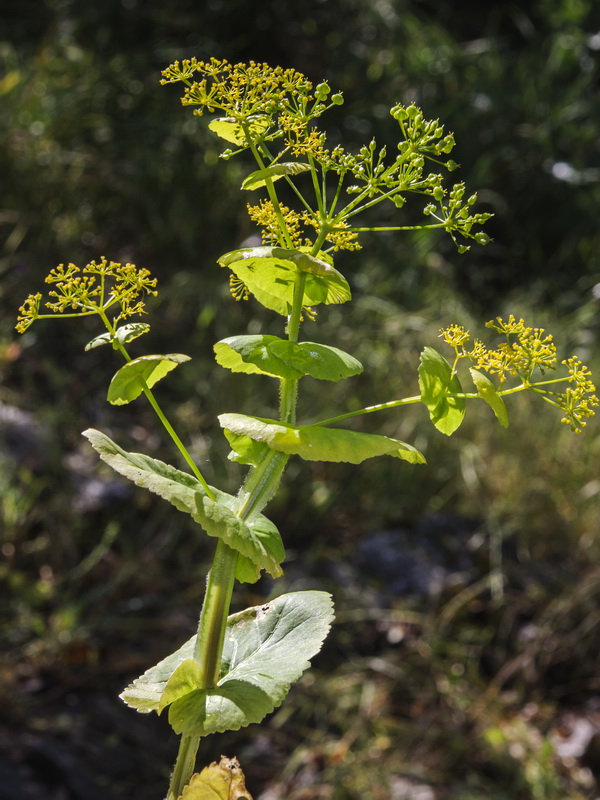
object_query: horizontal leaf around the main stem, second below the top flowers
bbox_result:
[214,335,362,381]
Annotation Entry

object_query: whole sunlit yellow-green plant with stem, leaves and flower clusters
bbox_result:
[17,59,598,800]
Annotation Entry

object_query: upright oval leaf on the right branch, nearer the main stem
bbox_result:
[419,347,465,436]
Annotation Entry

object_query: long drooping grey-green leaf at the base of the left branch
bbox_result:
[83,429,285,578]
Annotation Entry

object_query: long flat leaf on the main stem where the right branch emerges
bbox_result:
[219,414,425,464]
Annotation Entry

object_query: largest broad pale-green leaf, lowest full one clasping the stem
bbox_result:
[121,591,333,736]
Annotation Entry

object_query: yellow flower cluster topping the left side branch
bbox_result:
[16,257,157,333]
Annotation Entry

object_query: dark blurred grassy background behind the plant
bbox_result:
[0,0,600,800]
